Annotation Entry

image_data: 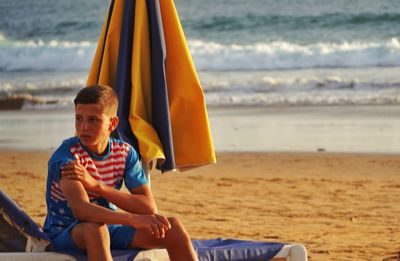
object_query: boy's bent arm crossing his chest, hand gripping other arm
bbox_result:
[61,161,157,214]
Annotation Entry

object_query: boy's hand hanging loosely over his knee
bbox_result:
[132,214,171,238]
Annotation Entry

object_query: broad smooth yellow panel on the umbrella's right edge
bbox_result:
[160,0,216,170]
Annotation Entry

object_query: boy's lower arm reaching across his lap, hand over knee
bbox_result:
[60,177,171,238]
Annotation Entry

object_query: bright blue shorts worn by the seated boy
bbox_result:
[51,222,136,254]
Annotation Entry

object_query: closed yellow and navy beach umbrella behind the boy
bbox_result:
[87,0,216,171]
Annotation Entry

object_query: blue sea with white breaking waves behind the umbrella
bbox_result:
[0,0,400,106]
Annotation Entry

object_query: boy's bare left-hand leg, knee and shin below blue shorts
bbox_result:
[71,222,112,261]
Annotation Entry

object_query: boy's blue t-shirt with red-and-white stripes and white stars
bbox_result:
[44,137,147,237]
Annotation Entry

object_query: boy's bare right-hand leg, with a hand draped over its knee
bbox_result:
[130,215,198,261]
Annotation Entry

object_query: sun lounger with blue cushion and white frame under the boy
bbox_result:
[0,191,307,261]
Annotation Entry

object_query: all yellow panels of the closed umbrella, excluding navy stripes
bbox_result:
[87,0,216,170]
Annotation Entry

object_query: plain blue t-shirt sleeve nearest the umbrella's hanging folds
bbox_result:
[124,148,147,191]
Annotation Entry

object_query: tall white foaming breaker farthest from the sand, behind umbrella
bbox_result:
[0,35,400,72]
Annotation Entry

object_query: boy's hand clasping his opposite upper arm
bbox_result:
[61,161,99,192]
